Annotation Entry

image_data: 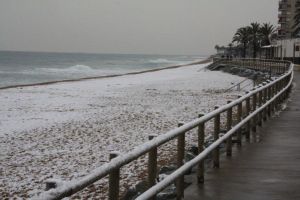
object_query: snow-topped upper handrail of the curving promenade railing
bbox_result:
[38,59,293,199]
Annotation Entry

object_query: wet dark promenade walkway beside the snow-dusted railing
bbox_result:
[184,72,300,200]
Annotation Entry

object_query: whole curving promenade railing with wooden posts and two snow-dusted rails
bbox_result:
[38,59,293,200]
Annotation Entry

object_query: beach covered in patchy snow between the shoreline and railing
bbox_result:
[0,64,244,198]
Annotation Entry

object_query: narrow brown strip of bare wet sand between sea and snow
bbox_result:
[0,57,212,90]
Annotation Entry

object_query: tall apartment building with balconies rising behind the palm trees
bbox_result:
[278,0,297,39]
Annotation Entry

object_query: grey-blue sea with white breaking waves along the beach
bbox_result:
[0,51,207,88]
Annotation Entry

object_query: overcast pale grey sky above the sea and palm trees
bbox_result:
[0,0,278,55]
